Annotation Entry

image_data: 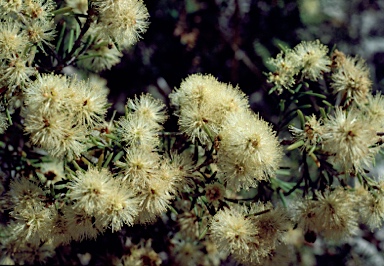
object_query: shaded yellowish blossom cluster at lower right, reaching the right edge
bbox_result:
[295,187,384,242]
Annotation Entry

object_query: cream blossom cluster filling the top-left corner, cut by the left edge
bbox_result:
[0,0,56,95]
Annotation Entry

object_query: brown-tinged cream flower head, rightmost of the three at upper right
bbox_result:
[331,57,372,103]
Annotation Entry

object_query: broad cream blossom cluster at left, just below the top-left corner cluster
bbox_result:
[24,74,107,159]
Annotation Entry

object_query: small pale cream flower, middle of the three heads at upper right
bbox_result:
[294,40,331,81]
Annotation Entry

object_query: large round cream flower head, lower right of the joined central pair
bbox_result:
[217,111,282,190]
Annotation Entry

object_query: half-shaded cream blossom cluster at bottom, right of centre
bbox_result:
[210,203,292,264]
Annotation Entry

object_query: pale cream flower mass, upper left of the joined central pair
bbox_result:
[169,74,249,145]
